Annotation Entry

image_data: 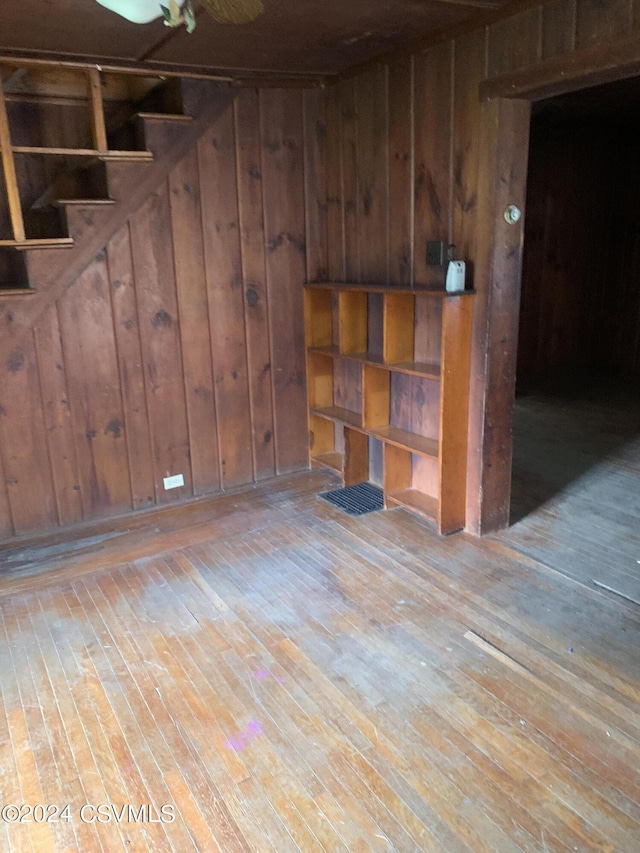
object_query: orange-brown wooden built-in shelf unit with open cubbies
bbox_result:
[305,282,473,533]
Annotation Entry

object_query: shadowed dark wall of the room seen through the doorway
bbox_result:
[518,116,640,381]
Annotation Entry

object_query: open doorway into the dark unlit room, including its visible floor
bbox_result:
[508,78,640,603]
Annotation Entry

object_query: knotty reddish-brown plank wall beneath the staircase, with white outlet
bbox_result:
[0,89,326,538]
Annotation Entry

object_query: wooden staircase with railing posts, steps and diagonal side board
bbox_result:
[0,69,234,361]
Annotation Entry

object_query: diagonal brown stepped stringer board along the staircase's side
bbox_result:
[0,80,237,370]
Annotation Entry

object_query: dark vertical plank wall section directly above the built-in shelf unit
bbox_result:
[327,44,466,284]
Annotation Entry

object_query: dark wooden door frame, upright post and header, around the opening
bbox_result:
[466,51,640,535]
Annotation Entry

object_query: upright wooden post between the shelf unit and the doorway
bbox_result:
[466,98,531,534]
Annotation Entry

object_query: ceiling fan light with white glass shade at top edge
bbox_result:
[97,0,264,33]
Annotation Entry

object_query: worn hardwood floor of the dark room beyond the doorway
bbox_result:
[498,376,640,606]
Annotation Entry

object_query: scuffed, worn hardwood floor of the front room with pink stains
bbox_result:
[0,471,640,853]
